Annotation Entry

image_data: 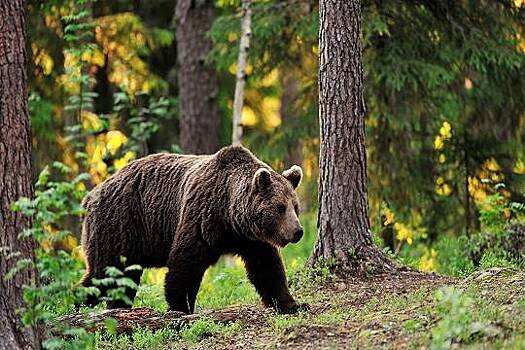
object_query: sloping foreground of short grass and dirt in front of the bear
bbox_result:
[92,268,525,349]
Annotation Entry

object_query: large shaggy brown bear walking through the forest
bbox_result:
[82,146,303,314]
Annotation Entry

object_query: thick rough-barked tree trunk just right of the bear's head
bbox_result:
[310,0,395,273]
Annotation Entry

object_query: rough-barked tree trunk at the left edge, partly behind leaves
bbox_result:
[0,0,40,350]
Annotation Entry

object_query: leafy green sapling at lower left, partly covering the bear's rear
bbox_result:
[10,162,140,349]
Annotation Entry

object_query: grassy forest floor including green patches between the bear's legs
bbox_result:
[95,208,525,349]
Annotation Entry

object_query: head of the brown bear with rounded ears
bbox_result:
[250,165,303,247]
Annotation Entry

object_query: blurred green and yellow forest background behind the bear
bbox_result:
[27,0,525,272]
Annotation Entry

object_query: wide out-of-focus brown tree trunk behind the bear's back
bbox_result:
[175,0,219,154]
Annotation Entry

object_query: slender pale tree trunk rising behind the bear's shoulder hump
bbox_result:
[232,0,252,145]
